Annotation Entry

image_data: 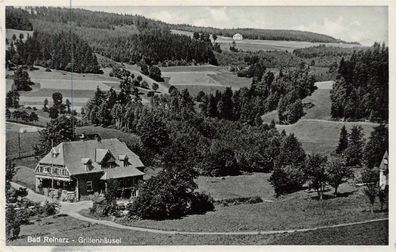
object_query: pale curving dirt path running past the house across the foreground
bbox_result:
[11,182,388,235]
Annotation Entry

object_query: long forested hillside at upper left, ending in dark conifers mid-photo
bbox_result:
[22,8,217,65]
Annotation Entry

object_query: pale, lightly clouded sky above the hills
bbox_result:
[82,6,388,45]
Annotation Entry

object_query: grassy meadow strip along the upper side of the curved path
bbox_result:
[82,178,388,232]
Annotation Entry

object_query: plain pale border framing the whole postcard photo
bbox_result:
[0,0,396,252]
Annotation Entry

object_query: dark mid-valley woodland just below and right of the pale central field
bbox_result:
[197,60,315,125]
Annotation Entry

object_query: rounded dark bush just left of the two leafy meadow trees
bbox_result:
[269,165,305,197]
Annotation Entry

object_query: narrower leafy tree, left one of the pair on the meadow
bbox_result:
[304,154,328,200]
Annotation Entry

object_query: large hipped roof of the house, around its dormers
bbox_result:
[39,138,144,175]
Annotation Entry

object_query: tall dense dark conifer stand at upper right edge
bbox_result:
[331,43,389,122]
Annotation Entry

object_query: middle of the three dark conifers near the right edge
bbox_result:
[345,125,364,166]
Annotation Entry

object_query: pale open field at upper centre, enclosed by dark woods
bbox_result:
[161,65,251,95]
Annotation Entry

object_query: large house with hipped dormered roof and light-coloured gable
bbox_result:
[35,138,144,200]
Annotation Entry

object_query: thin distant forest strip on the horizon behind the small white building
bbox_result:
[169,24,344,43]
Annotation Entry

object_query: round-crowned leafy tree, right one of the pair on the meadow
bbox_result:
[326,157,353,197]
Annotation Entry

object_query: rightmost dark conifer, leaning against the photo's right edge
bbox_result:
[363,124,389,168]
